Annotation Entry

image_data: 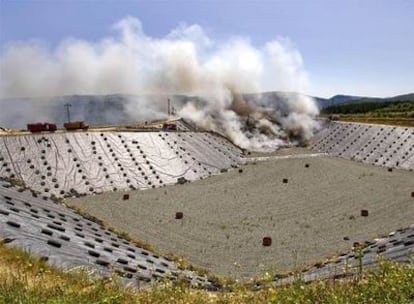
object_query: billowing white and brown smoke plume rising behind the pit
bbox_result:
[0,17,318,150]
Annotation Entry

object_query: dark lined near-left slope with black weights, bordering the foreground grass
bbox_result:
[0,181,216,289]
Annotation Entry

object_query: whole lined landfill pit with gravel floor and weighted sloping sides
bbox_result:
[0,120,414,290]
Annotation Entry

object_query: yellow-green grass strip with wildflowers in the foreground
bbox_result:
[0,245,414,304]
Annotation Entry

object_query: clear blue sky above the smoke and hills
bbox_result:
[0,0,414,97]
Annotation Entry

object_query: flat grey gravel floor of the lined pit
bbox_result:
[69,156,414,279]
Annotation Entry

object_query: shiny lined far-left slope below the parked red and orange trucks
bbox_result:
[0,132,241,197]
